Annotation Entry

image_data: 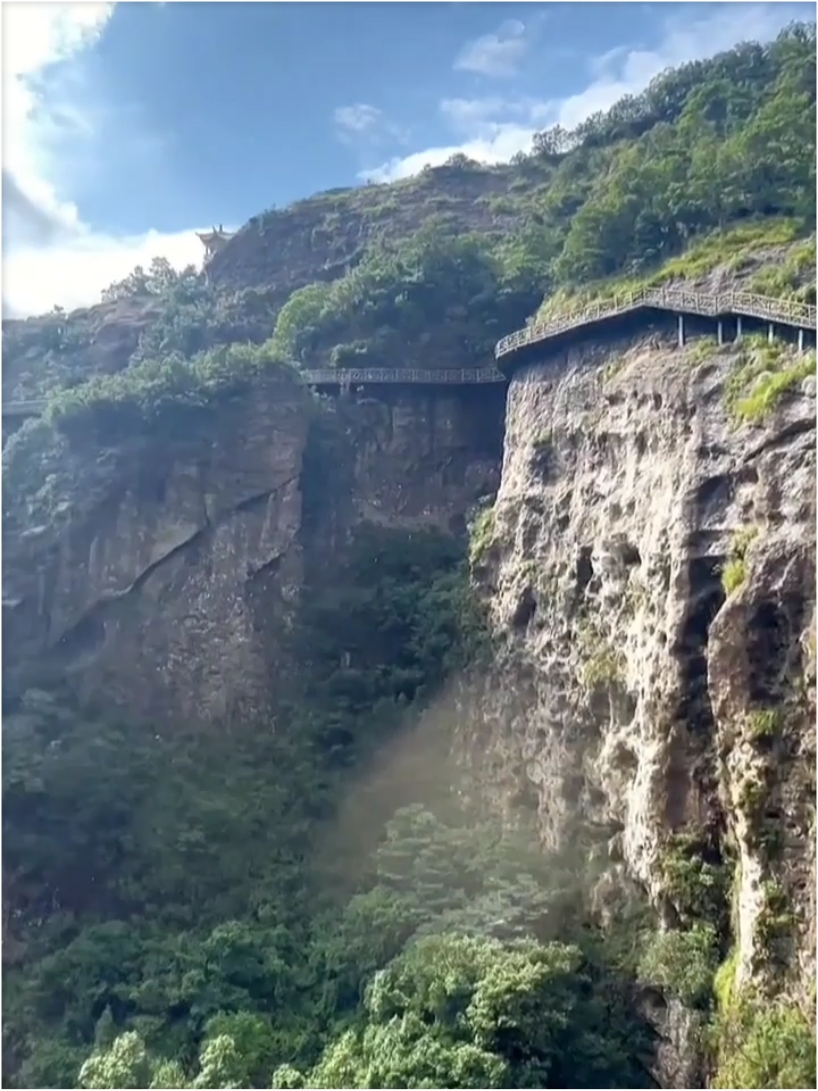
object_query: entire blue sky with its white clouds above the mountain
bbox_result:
[2,2,815,314]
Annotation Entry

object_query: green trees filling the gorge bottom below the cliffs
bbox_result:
[3,528,651,1088]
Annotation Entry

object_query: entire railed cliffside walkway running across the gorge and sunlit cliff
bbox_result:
[2,288,816,418]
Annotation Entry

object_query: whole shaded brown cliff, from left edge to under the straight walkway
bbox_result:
[3,384,505,723]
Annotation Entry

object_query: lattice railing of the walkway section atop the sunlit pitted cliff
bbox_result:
[494,288,816,360]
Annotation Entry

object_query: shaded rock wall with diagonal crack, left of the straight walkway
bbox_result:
[3,381,310,722]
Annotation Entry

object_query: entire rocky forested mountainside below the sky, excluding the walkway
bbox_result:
[3,26,816,1088]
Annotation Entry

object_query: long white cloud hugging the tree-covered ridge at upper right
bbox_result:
[361,3,798,182]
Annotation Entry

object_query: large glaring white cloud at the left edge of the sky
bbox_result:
[2,0,202,315]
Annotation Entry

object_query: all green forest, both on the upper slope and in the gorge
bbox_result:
[2,26,816,1088]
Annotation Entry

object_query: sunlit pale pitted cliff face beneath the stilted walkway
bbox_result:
[462,324,815,1012]
